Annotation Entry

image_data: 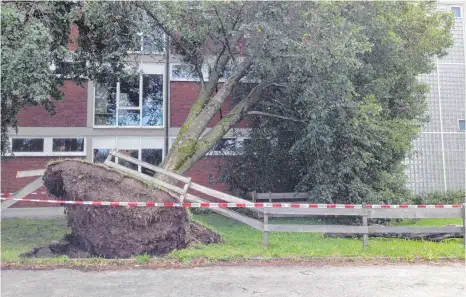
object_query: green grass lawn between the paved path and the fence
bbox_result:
[1,214,464,263]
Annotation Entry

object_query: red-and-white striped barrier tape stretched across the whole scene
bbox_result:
[0,197,463,209]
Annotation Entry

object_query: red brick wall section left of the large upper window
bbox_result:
[18,80,87,127]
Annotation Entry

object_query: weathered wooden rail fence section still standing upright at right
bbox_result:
[250,192,466,248]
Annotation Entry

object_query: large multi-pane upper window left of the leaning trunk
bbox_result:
[94,74,163,127]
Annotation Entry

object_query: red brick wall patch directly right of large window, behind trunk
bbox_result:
[170,81,248,128]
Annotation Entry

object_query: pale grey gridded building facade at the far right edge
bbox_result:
[406,0,466,194]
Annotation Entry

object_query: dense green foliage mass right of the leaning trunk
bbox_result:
[229,2,452,203]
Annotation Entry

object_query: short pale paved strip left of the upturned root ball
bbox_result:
[2,207,65,220]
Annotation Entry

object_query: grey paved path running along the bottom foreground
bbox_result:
[1,264,465,297]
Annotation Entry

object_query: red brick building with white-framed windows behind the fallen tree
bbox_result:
[1,28,248,206]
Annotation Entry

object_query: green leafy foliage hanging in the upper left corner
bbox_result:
[1,1,72,156]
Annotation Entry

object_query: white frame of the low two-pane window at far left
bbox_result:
[6,136,87,157]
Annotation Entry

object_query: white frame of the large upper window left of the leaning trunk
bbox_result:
[92,73,167,129]
